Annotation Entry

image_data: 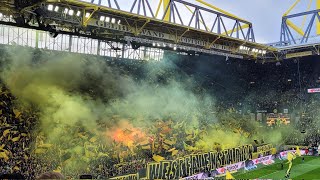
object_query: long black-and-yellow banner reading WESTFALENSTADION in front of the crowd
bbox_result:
[146,144,254,179]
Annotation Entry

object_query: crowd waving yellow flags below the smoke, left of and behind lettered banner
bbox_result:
[0,82,244,179]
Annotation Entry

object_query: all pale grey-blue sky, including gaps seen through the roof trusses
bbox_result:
[85,0,316,43]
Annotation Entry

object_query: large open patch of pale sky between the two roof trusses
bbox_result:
[198,0,298,43]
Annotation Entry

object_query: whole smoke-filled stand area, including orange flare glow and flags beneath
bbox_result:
[0,47,318,176]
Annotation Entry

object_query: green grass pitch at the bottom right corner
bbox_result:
[233,156,320,180]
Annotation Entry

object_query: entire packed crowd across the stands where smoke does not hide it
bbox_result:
[0,46,320,179]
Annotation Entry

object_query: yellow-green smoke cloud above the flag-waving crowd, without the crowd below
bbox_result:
[1,45,308,173]
